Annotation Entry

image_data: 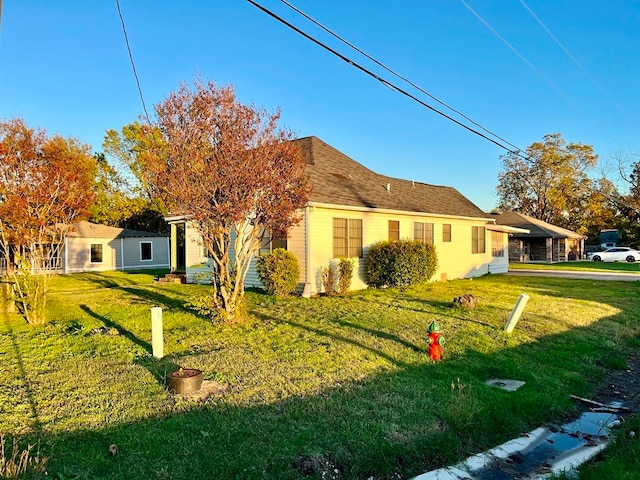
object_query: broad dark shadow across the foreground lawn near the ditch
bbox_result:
[35,318,632,480]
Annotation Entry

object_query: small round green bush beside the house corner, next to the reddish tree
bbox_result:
[256,248,300,297]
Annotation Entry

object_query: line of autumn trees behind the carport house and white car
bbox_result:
[496,133,640,246]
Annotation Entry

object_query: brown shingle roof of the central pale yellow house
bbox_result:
[297,137,489,218]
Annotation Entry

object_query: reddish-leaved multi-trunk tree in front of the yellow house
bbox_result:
[137,79,310,319]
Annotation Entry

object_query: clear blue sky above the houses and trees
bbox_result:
[0,0,640,211]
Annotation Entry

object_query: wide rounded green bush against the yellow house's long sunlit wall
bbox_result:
[367,240,438,288]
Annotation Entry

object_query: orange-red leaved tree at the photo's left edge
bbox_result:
[0,118,95,324]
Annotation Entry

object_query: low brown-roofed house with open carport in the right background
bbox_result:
[493,212,586,262]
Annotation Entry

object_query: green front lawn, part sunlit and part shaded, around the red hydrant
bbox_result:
[0,272,640,480]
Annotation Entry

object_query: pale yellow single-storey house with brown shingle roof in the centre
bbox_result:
[167,137,525,294]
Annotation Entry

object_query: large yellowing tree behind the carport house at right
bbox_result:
[496,133,598,230]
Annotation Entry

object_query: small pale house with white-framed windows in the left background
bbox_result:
[57,222,170,273]
